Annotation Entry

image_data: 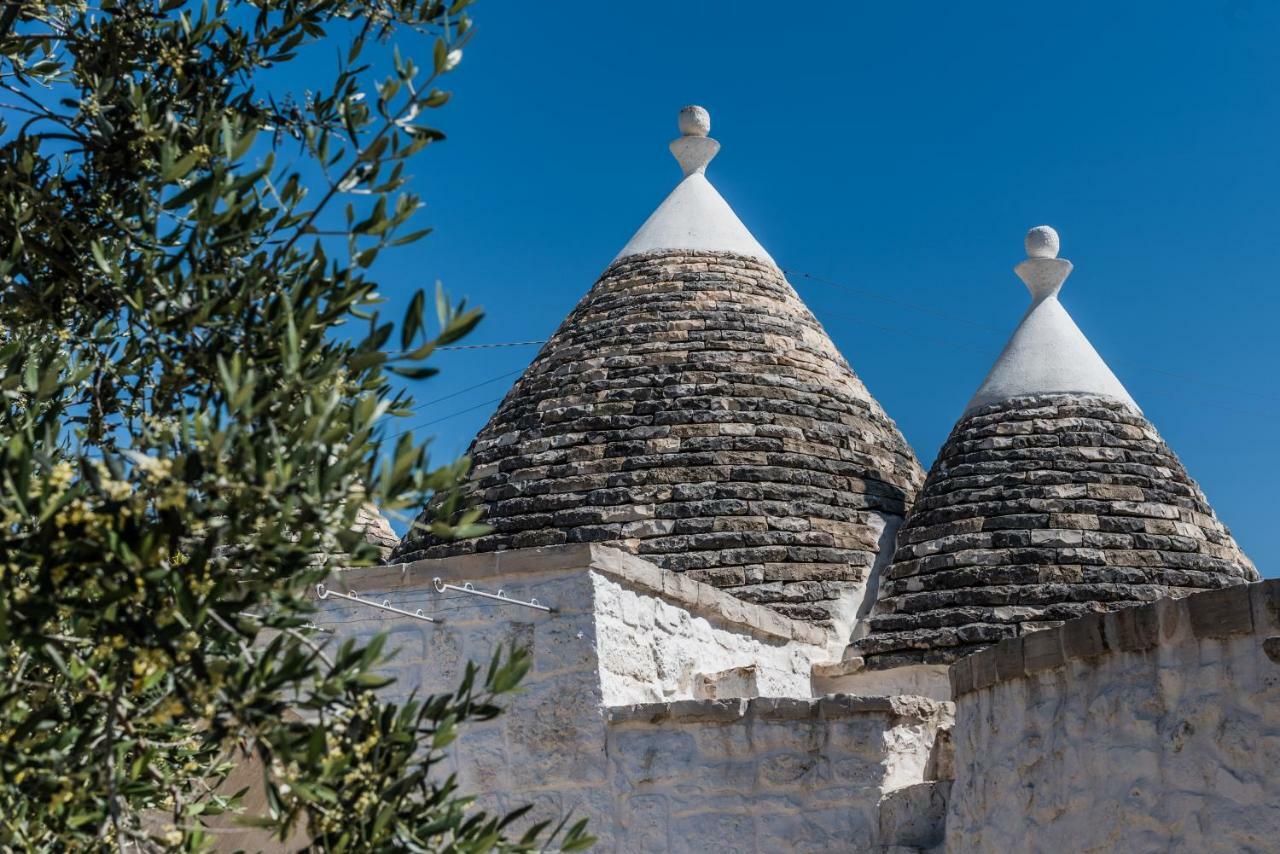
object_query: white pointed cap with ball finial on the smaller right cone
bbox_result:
[965,225,1138,414]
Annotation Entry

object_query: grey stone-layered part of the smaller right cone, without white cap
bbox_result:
[856,394,1257,668]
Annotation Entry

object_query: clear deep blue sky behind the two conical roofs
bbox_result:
[360,0,1280,576]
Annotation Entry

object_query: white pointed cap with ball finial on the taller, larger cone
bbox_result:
[613,106,774,264]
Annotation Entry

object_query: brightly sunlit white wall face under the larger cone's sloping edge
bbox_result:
[591,572,826,705]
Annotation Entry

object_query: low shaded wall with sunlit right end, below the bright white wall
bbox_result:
[598,695,950,854]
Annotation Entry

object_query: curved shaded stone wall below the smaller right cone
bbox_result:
[947,580,1280,853]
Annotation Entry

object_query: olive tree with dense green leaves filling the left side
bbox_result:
[0,0,590,851]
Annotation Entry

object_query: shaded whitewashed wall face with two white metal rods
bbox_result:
[316,570,612,818]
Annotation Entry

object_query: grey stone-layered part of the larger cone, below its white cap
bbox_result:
[394,252,923,621]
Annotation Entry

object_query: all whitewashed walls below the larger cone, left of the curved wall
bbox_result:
[299,552,951,854]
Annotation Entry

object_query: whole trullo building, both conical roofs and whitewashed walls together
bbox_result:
[230,108,1280,854]
